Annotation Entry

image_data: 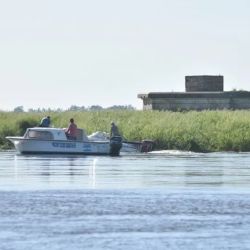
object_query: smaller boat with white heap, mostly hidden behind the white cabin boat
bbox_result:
[88,131,155,153]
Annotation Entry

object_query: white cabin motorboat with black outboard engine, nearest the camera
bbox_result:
[6,127,122,156]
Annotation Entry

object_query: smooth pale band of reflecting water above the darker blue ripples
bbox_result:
[0,151,250,190]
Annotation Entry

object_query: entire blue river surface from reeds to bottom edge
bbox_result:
[0,151,250,250]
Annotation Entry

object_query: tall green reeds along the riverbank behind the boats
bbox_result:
[0,110,250,152]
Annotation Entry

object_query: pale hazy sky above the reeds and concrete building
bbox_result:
[0,0,250,111]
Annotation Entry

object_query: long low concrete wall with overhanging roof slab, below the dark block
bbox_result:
[138,91,250,111]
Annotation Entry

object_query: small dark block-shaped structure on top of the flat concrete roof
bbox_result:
[185,75,223,92]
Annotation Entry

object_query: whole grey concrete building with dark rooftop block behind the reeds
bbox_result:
[138,75,250,111]
